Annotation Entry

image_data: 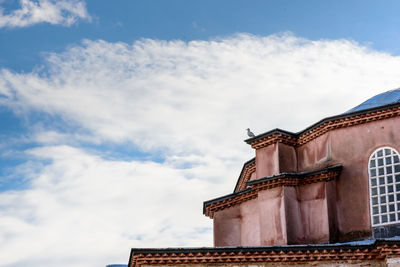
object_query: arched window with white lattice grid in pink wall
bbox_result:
[368,147,400,226]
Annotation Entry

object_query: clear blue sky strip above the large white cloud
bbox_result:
[0,0,400,71]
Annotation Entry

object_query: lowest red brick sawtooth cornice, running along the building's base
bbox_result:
[129,240,400,267]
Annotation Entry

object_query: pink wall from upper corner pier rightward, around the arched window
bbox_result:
[297,118,400,240]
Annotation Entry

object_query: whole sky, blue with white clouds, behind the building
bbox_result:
[0,0,400,267]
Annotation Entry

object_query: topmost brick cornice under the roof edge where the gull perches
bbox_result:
[245,103,400,149]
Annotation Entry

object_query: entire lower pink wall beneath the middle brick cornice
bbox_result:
[214,182,334,246]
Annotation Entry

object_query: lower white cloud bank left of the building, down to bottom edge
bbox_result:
[0,146,221,267]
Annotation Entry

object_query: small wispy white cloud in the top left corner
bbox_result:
[0,0,91,28]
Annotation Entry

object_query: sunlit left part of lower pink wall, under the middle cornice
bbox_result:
[214,187,287,247]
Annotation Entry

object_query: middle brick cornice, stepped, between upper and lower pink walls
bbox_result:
[203,165,342,218]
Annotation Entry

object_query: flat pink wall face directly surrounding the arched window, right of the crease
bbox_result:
[331,118,400,238]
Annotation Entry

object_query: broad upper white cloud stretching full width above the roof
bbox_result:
[0,35,400,157]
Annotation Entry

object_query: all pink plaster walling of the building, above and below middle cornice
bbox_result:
[214,118,400,246]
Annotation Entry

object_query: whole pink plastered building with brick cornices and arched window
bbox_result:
[129,89,400,267]
